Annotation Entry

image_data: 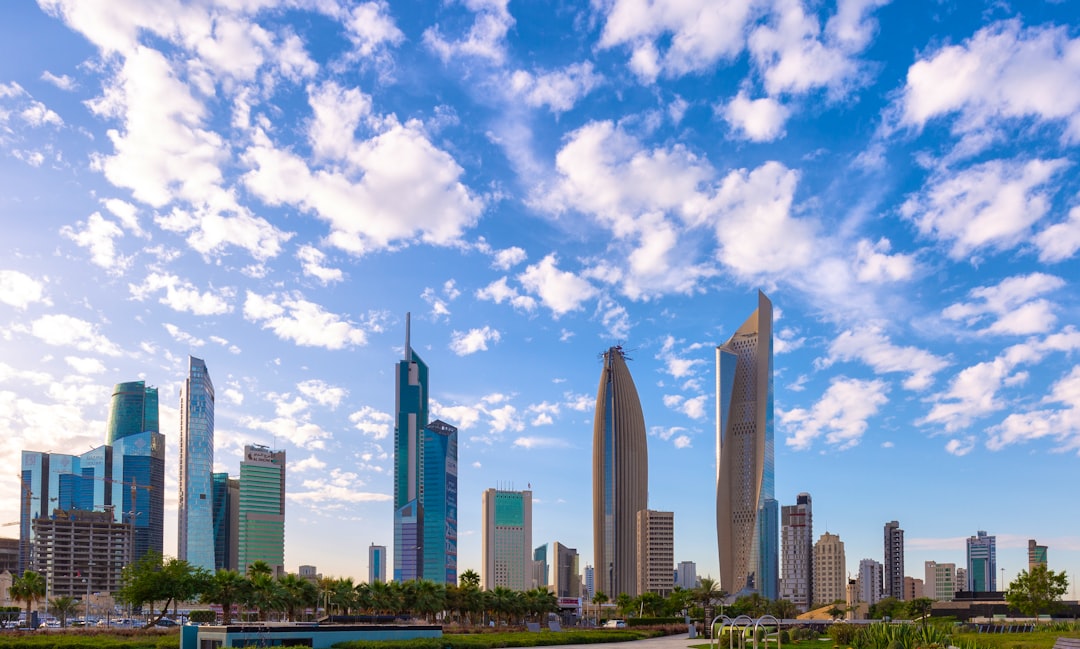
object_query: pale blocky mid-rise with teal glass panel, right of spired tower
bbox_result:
[481,489,532,591]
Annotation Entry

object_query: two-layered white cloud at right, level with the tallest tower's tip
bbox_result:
[942,273,1065,335]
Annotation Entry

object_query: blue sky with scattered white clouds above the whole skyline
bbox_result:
[0,0,1080,581]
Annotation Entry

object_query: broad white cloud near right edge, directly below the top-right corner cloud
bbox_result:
[900,159,1069,259]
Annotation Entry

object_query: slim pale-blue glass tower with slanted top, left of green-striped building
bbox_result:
[176,356,214,570]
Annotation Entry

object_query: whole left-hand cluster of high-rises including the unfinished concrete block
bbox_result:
[5,356,285,597]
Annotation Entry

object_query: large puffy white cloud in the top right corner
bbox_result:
[901,19,1080,141]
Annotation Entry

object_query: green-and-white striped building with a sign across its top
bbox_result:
[237,445,285,574]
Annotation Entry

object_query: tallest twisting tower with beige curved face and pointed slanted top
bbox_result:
[716,290,779,595]
